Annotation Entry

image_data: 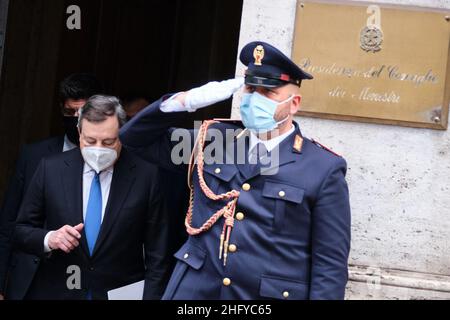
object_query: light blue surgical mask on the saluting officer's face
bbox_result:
[241,92,294,133]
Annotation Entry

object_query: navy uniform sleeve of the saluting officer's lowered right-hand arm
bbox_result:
[310,158,350,300]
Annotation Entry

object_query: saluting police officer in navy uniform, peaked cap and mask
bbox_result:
[121,41,350,300]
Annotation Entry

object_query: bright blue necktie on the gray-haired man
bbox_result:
[84,173,102,255]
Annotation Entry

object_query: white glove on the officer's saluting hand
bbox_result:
[184,77,244,112]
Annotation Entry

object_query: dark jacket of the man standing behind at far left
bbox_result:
[0,136,64,299]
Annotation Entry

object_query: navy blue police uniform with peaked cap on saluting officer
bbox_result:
[121,42,350,300]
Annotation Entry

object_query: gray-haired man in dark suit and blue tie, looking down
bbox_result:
[14,96,170,299]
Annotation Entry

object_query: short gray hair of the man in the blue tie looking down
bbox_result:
[78,95,127,131]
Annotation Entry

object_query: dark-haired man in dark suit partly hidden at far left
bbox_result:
[0,73,102,300]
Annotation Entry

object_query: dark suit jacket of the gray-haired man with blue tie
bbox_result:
[14,149,170,300]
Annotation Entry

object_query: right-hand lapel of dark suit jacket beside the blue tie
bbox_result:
[92,149,136,256]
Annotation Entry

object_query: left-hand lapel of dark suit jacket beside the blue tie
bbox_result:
[61,149,89,256]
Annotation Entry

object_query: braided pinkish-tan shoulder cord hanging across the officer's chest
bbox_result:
[185,120,240,266]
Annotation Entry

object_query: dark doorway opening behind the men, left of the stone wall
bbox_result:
[0,0,242,201]
